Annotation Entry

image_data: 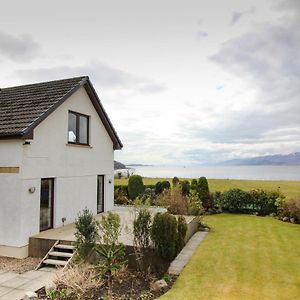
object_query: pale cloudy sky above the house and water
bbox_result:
[0,0,300,165]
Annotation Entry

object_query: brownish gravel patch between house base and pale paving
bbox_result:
[0,256,41,274]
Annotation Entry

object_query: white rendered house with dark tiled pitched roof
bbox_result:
[0,77,122,257]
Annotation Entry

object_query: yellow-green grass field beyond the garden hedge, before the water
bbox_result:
[115,178,300,198]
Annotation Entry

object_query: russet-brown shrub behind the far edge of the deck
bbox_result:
[157,186,187,215]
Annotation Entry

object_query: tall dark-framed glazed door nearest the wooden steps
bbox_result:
[40,178,54,231]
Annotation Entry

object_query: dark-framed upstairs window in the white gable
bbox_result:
[68,111,89,145]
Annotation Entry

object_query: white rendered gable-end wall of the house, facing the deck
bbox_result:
[8,88,114,247]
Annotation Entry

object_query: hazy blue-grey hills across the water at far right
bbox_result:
[220,152,300,166]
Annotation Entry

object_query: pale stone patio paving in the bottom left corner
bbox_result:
[0,268,56,300]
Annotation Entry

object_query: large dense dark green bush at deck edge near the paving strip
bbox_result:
[151,212,178,261]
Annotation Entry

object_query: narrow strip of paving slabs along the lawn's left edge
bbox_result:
[168,231,207,276]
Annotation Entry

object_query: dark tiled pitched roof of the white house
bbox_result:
[0,76,123,149]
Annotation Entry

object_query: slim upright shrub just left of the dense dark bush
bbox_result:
[133,209,151,248]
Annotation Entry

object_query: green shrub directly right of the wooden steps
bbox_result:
[74,208,98,260]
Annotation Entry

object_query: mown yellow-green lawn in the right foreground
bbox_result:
[160,214,300,300]
